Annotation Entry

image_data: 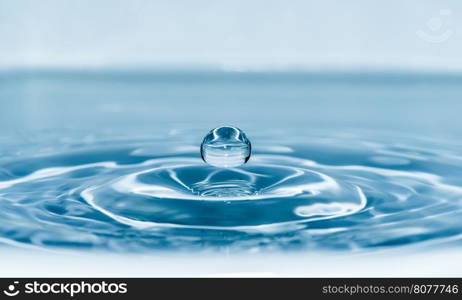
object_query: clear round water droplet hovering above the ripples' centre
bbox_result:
[201,126,252,168]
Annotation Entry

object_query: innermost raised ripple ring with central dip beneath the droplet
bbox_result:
[82,156,366,228]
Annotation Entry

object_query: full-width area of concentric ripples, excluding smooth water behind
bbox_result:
[0,129,462,251]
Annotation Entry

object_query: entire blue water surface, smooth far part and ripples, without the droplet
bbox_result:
[0,71,462,252]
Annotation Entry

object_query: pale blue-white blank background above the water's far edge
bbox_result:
[0,0,462,70]
